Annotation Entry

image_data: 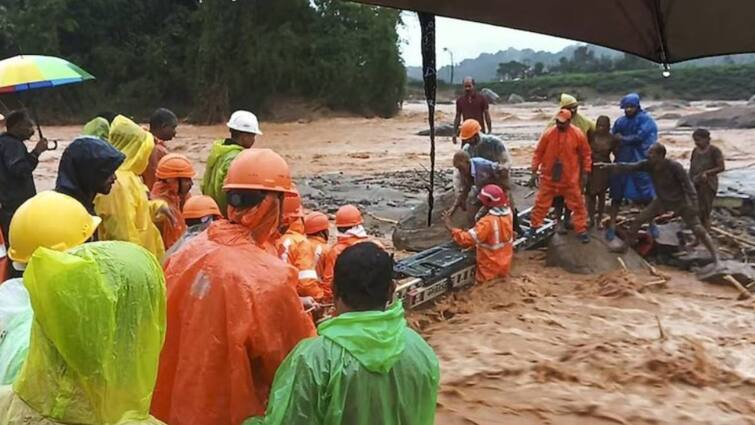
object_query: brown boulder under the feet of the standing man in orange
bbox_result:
[545,231,645,274]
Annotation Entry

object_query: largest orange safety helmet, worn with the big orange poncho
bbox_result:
[223,149,296,193]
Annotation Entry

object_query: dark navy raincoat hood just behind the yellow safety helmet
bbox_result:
[55,136,126,215]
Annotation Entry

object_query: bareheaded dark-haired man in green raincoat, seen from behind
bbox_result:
[245,243,440,425]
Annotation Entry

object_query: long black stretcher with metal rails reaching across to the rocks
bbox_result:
[394,208,556,308]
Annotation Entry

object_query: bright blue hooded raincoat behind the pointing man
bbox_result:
[611,93,658,201]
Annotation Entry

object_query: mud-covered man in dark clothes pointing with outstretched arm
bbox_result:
[595,143,720,268]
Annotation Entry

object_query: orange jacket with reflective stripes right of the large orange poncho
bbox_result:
[278,218,324,300]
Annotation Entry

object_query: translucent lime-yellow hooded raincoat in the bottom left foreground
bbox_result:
[14,242,166,425]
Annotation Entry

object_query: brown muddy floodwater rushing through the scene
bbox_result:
[36,102,755,425]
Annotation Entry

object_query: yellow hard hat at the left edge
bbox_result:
[8,191,102,264]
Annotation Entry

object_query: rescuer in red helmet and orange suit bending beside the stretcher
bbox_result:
[444,184,514,283]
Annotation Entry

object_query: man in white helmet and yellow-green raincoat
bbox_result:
[202,111,262,217]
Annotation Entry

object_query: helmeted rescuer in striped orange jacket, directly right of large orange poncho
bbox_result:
[278,193,324,300]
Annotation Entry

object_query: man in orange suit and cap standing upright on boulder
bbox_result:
[530,109,592,243]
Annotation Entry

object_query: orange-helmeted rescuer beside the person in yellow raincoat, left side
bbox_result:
[150,153,196,250]
